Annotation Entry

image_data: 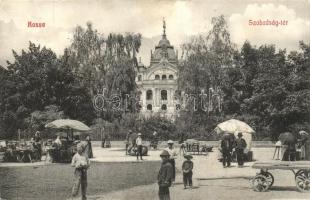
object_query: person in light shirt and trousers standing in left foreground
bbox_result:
[71,143,90,200]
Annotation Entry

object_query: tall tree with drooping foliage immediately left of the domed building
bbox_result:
[68,23,141,121]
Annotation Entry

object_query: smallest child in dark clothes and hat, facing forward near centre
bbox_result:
[182,154,194,189]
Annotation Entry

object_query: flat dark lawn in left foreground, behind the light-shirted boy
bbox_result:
[0,161,160,200]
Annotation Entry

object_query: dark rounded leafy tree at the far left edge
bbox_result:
[0,42,57,136]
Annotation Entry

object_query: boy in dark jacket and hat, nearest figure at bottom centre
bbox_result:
[157,150,173,200]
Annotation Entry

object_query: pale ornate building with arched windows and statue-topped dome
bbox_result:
[136,21,180,119]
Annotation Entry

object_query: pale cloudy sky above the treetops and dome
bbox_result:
[0,0,310,66]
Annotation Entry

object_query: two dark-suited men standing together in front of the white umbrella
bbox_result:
[220,132,247,167]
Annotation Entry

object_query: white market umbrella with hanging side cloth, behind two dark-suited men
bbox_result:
[215,119,255,153]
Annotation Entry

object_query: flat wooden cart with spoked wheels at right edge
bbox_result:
[252,161,310,192]
